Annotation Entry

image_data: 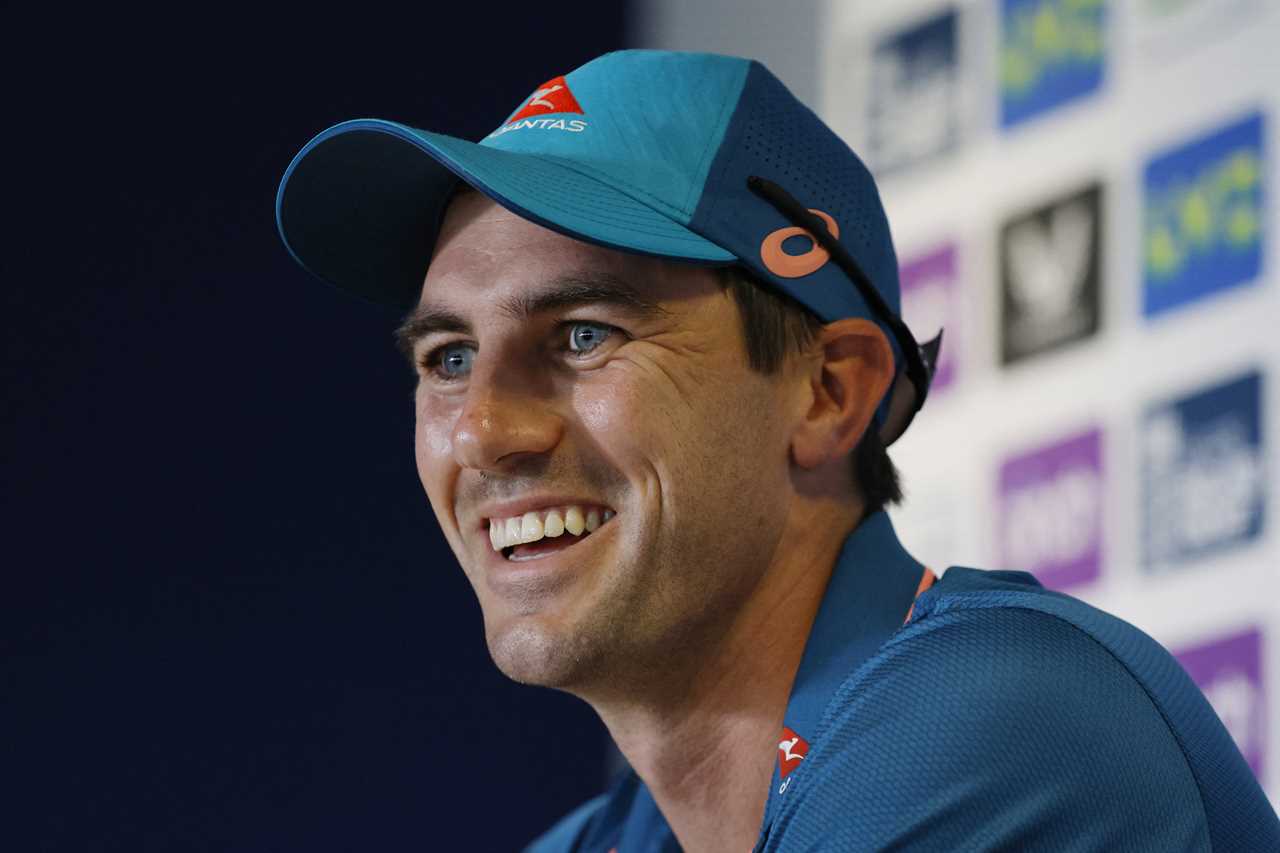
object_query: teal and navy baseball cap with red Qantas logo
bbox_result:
[275,50,941,444]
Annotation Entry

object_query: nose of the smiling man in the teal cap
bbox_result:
[453,359,564,471]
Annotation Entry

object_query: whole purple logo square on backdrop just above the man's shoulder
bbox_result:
[998,429,1102,590]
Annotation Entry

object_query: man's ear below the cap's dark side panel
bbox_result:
[791,318,893,467]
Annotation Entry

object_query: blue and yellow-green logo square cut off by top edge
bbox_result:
[1000,0,1107,128]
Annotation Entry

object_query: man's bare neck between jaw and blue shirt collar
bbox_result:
[584,499,858,853]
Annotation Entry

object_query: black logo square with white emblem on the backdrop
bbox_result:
[1000,184,1102,365]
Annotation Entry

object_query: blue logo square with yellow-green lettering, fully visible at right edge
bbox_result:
[1142,113,1265,316]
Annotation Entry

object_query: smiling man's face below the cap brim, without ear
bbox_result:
[411,193,800,692]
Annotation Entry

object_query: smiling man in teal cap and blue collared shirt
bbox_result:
[276,51,1280,853]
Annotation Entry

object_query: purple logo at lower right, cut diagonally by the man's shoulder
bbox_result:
[1174,628,1267,780]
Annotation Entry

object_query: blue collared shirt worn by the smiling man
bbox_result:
[527,512,1280,853]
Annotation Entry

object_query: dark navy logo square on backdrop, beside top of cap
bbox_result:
[867,9,961,174]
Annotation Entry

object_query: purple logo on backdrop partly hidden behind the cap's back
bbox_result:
[899,243,960,393]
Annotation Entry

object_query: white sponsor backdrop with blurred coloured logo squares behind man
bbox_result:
[818,0,1280,802]
